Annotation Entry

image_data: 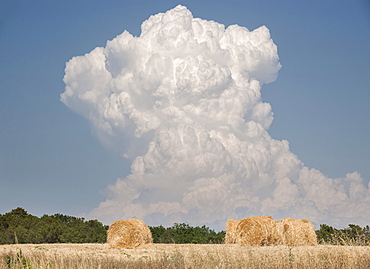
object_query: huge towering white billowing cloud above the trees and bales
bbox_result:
[61,6,370,229]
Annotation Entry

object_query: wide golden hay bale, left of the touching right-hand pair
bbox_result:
[225,216,282,246]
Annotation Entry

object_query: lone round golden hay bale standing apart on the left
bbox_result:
[107,219,153,248]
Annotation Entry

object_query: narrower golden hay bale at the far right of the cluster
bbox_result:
[280,218,317,246]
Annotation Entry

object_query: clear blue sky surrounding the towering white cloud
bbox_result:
[0,0,370,226]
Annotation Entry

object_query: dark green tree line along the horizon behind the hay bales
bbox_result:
[0,207,370,245]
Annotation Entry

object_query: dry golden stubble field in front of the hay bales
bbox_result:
[0,244,370,269]
